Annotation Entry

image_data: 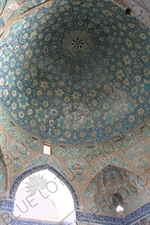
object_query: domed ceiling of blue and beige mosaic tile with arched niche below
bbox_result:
[0,0,150,221]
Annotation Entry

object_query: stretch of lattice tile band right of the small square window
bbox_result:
[53,119,150,158]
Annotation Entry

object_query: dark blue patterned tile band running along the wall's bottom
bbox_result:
[0,200,150,225]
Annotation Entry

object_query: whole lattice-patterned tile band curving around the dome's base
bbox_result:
[0,103,150,162]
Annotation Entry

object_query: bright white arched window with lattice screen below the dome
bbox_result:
[13,169,75,223]
